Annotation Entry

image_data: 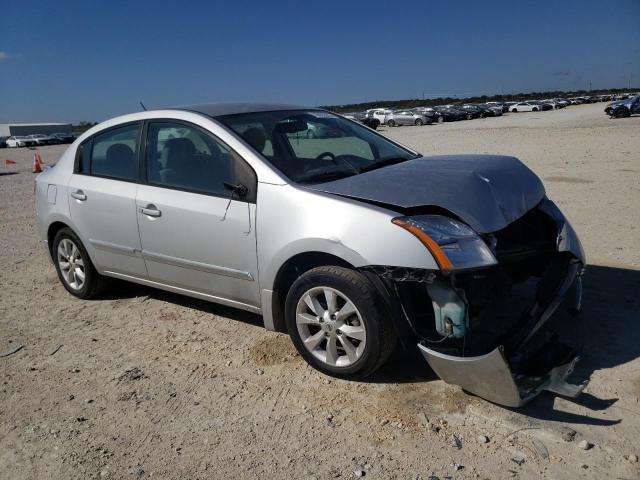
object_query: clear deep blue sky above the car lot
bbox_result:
[0,0,640,122]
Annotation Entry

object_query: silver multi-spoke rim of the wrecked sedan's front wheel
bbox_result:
[296,287,367,367]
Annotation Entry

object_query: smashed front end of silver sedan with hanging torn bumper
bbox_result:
[366,198,585,407]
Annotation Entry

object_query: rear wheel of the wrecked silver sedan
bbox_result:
[51,228,104,299]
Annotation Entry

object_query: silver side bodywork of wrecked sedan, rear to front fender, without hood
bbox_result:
[36,104,437,318]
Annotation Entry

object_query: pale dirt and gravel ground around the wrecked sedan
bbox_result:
[0,104,640,480]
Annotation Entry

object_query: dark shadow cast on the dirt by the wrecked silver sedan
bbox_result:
[101,265,640,425]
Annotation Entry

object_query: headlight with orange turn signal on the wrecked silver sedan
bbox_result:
[391,215,498,270]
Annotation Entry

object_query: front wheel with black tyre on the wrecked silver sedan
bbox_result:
[285,266,396,379]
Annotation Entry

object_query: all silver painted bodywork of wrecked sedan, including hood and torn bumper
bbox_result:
[36,105,584,406]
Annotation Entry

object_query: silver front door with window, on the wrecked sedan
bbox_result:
[136,121,259,306]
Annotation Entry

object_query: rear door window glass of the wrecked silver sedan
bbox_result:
[88,124,140,180]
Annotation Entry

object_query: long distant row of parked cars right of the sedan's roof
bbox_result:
[345,94,632,129]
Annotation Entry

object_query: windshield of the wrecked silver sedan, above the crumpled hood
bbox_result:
[216,110,419,183]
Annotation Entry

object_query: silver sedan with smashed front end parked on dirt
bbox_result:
[35,104,585,406]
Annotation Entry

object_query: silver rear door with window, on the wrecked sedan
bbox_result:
[67,122,147,278]
